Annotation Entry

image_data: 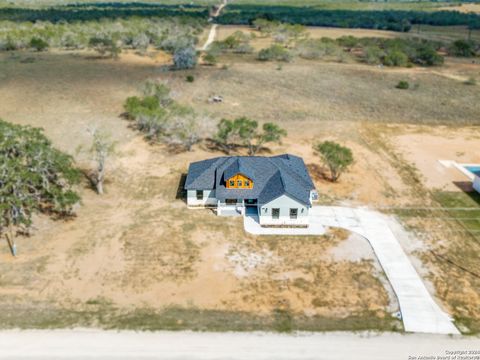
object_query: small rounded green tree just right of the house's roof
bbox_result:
[314,141,353,182]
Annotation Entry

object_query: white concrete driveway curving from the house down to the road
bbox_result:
[244,206,459,334]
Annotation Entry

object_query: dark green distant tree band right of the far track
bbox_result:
[215,4,480,32]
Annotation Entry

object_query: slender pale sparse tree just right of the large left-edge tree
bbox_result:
[86,129,115,195]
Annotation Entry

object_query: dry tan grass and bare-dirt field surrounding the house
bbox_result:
[0,25,480,331]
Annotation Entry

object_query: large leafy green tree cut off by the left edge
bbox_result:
[0,120,81,253]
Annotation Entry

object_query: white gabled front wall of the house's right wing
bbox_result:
[258,195,308,225]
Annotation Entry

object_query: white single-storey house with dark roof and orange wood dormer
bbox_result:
[185,154,318,227]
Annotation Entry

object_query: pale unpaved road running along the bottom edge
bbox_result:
[0,330,480,360]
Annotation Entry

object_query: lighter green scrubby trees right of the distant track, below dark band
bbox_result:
[211,19,480,66]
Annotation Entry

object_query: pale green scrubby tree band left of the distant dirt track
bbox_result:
[0,18,205,56]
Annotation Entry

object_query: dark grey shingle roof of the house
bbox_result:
[185,154,315,205]
